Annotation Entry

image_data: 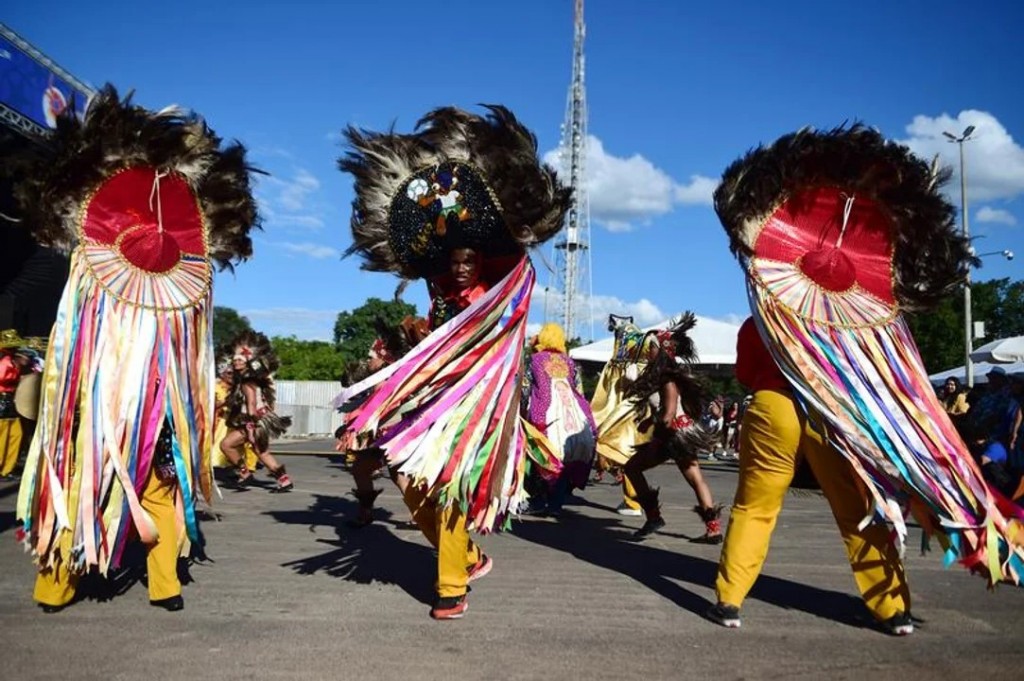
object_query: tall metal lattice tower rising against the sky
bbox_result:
[545,0,594,340]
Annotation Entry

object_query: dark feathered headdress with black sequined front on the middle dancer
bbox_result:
[338,105,570,279]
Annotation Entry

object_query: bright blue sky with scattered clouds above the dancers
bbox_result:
[0,0,1024,338]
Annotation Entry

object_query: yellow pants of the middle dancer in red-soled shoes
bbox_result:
[402,484,482,598]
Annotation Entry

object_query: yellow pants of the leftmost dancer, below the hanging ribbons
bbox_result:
[33,466,181,605]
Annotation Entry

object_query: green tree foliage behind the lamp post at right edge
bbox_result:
[907,279,1024,373]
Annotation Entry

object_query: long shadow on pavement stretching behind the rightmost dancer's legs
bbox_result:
[513,511,873,627]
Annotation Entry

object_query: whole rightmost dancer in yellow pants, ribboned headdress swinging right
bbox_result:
[708,126,1024,635]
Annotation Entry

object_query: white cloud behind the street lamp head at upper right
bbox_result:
[900,110,1024,201]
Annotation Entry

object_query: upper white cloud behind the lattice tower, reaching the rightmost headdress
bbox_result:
[544,135,718,231]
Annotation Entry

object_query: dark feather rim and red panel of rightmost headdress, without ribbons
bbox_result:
[715,125,975,310]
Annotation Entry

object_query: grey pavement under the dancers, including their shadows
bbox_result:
[0,440,1024,681]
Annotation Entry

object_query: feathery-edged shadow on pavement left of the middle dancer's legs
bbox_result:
[267,495,436,605]
